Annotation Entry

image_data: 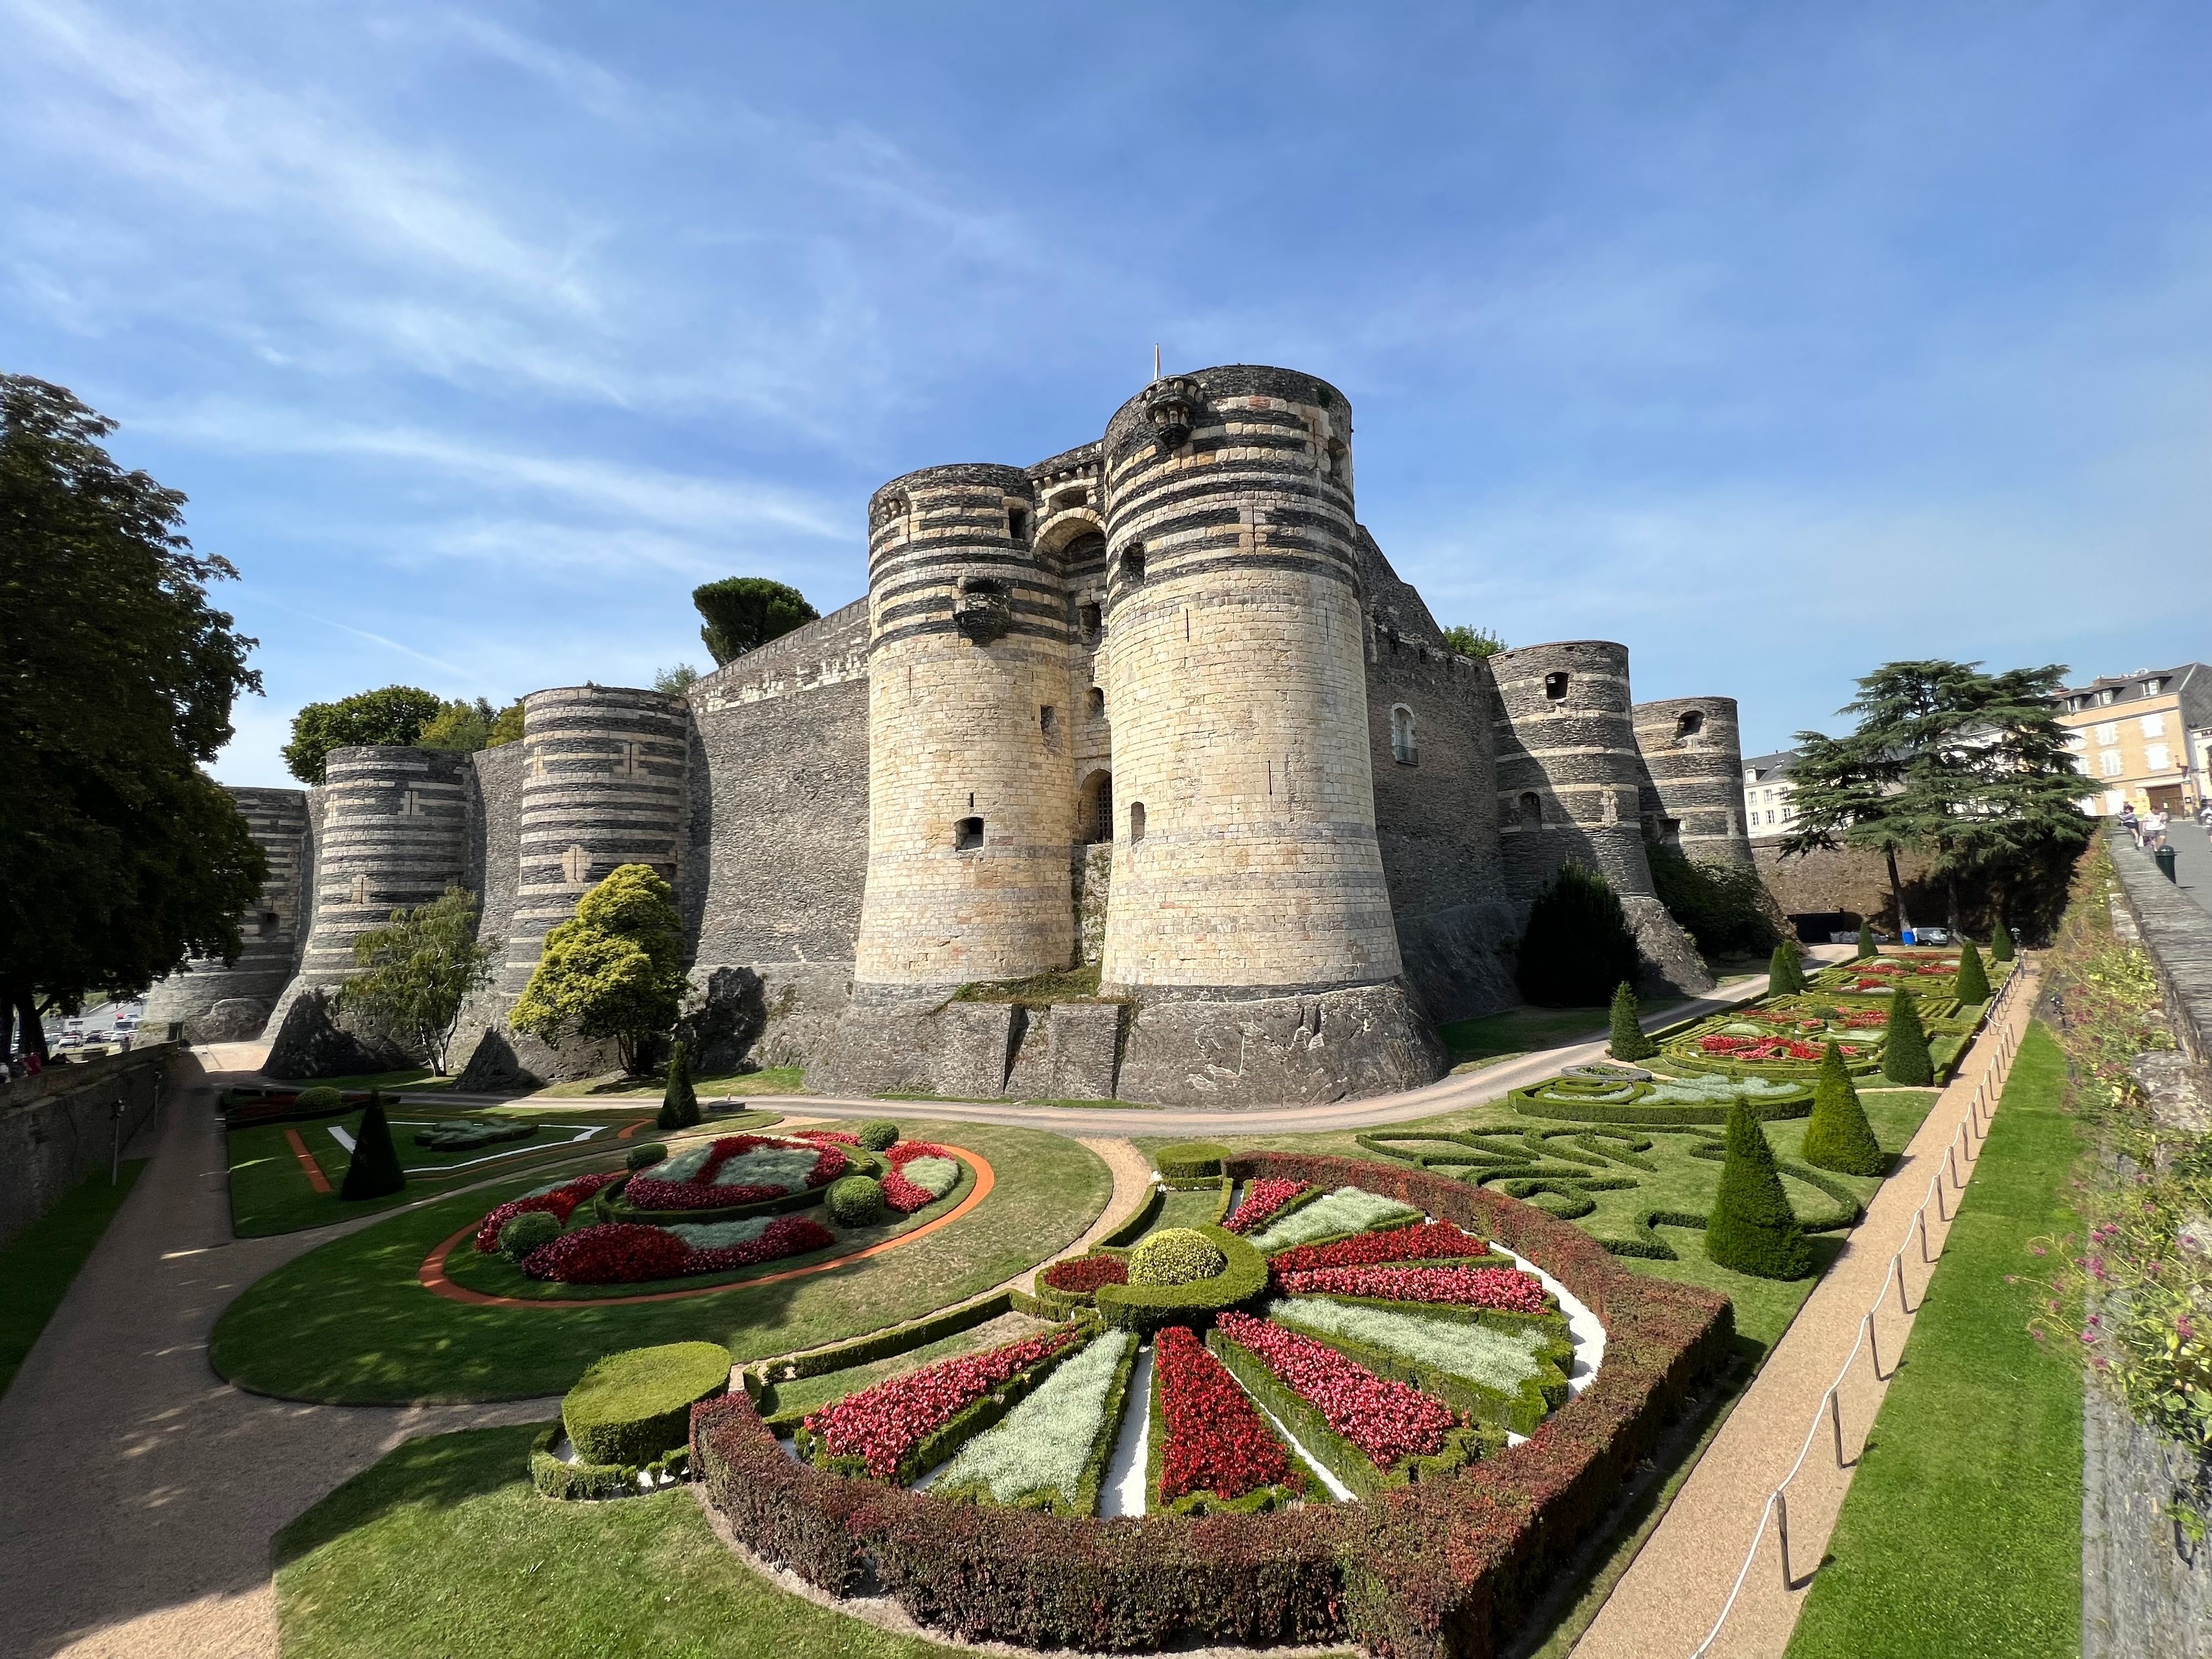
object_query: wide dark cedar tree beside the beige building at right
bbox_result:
[1783,662,2092,934]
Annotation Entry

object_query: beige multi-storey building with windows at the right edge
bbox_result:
[2059,662,2212,819]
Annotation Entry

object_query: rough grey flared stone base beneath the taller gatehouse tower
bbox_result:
[1119,984,1449,1108]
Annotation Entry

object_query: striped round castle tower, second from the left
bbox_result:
[292,748,469,1000]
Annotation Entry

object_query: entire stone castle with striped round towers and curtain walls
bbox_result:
[146,365,1752,1106]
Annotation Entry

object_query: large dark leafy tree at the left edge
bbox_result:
[0,374,268,1055]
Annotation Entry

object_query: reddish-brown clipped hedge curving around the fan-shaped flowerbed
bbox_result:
[692,1153,1734,1659]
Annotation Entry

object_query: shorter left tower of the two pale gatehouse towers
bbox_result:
[854,465,1077,986]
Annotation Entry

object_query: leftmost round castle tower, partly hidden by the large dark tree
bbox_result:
[146,785,307,1042]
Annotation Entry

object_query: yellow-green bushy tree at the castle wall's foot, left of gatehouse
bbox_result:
[506,865,686,1073]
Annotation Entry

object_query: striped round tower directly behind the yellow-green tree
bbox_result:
[500,686,690,1002]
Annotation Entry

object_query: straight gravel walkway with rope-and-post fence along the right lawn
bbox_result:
[1575,960,2035,1659]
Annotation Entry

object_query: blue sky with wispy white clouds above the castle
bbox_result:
[0,0,2212,783]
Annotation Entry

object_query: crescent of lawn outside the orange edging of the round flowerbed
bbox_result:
[210,1124,1113,1404]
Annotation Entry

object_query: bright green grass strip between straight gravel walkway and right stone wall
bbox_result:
[1790,1026,2081,1659]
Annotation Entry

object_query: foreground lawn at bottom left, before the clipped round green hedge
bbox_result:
[276,1427,956,1659]
